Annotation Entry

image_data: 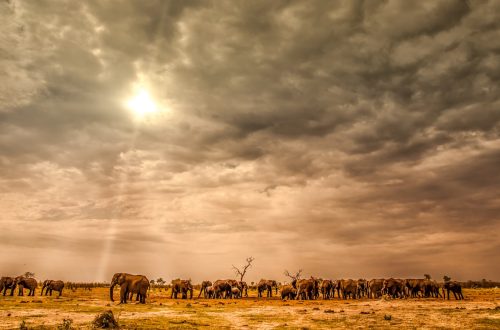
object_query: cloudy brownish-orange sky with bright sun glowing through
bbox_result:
[0,0,500,281]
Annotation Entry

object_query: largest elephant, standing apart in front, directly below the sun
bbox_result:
[109,273,150,304]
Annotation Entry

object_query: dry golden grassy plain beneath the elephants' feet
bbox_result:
[0,288,500,329]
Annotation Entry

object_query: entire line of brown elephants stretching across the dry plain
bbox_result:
[0,273,464,304]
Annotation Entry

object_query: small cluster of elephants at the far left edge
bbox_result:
[0,276,64,297]
